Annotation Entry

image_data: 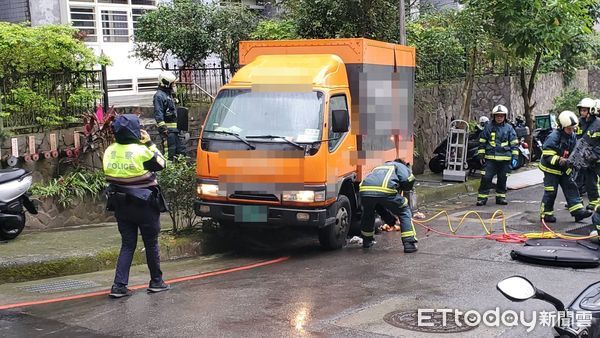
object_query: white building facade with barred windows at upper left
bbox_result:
[0,0,160,101]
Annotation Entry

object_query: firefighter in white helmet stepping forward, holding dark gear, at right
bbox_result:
[539,110,592,223]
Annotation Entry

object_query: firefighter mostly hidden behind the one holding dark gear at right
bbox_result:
[576,97,600,210]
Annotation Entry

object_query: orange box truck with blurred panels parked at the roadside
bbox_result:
[194,38,415,249]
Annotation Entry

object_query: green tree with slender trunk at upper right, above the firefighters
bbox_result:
[466,0,598,149]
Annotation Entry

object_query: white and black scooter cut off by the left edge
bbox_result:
[0,168,37,240]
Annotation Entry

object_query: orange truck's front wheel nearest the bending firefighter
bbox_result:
[319,195,352,250]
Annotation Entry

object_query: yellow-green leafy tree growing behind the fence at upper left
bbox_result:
[0,22,105,126]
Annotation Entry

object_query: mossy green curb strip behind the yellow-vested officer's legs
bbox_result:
[0,232,227,284]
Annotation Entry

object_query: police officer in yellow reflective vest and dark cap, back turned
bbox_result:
[103,114,169,298]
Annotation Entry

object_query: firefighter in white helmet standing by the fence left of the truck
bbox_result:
[154,72,185,161]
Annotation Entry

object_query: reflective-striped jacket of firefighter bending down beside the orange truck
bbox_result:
[359,161,415,196]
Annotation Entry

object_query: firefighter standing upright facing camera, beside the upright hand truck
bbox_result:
[477,105,519,206]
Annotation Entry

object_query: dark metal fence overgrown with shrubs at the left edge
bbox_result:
[0,67,108,130]
